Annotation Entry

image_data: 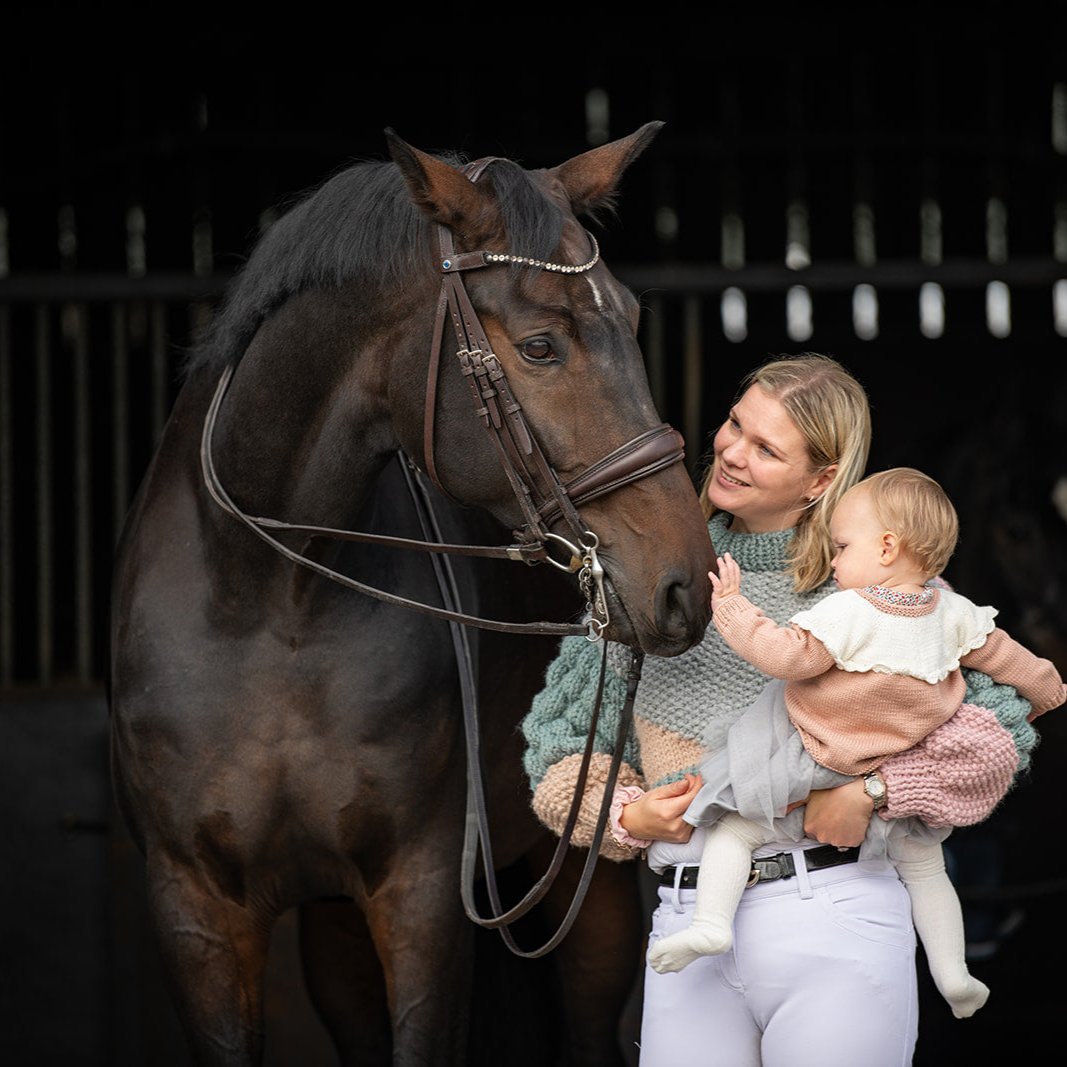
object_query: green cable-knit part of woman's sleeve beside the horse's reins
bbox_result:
[522,637,640,789]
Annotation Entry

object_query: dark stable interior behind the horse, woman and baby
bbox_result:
[0,10,1067,1065]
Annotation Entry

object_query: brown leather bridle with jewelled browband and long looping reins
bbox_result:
[201,157,685,958]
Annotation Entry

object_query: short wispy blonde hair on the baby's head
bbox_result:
[849,467,959,578]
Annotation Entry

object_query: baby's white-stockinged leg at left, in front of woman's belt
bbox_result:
[649,812,770,974]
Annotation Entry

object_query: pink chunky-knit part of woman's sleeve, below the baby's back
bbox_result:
[878,704,1019,827]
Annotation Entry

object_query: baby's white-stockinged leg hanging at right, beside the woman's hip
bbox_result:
[889,838,989,1019]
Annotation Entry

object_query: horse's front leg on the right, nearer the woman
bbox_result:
[365,834,474,1067]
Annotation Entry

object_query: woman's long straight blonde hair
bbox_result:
[700,352,871,592]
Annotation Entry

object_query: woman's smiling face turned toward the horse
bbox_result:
[706,385,833,534]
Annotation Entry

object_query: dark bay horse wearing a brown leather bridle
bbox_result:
[109,123,714,1067]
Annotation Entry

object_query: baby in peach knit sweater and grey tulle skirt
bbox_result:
[649,467,1067,1018]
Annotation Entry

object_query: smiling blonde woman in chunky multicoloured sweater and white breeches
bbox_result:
[524,354,1035,1067]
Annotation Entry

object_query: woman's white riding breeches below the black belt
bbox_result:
[640,850,919,1067]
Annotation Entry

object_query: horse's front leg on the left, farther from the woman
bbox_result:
[147,848,275,1067]
